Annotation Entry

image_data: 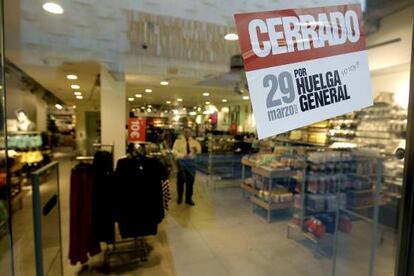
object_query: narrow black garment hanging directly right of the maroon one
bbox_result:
[92,151,115,244]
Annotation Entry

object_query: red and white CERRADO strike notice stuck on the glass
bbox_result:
[235,4,373,139]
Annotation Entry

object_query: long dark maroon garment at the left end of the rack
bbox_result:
[69,164,101,265]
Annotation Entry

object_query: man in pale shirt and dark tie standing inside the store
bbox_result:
[173,127,201,206]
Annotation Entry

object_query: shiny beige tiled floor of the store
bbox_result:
[9,152,394,276]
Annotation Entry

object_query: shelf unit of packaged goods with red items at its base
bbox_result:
[287,149,382,253]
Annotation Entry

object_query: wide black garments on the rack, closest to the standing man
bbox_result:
[114,156,167,238]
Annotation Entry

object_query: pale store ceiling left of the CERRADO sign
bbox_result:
[5,0,356,104]
